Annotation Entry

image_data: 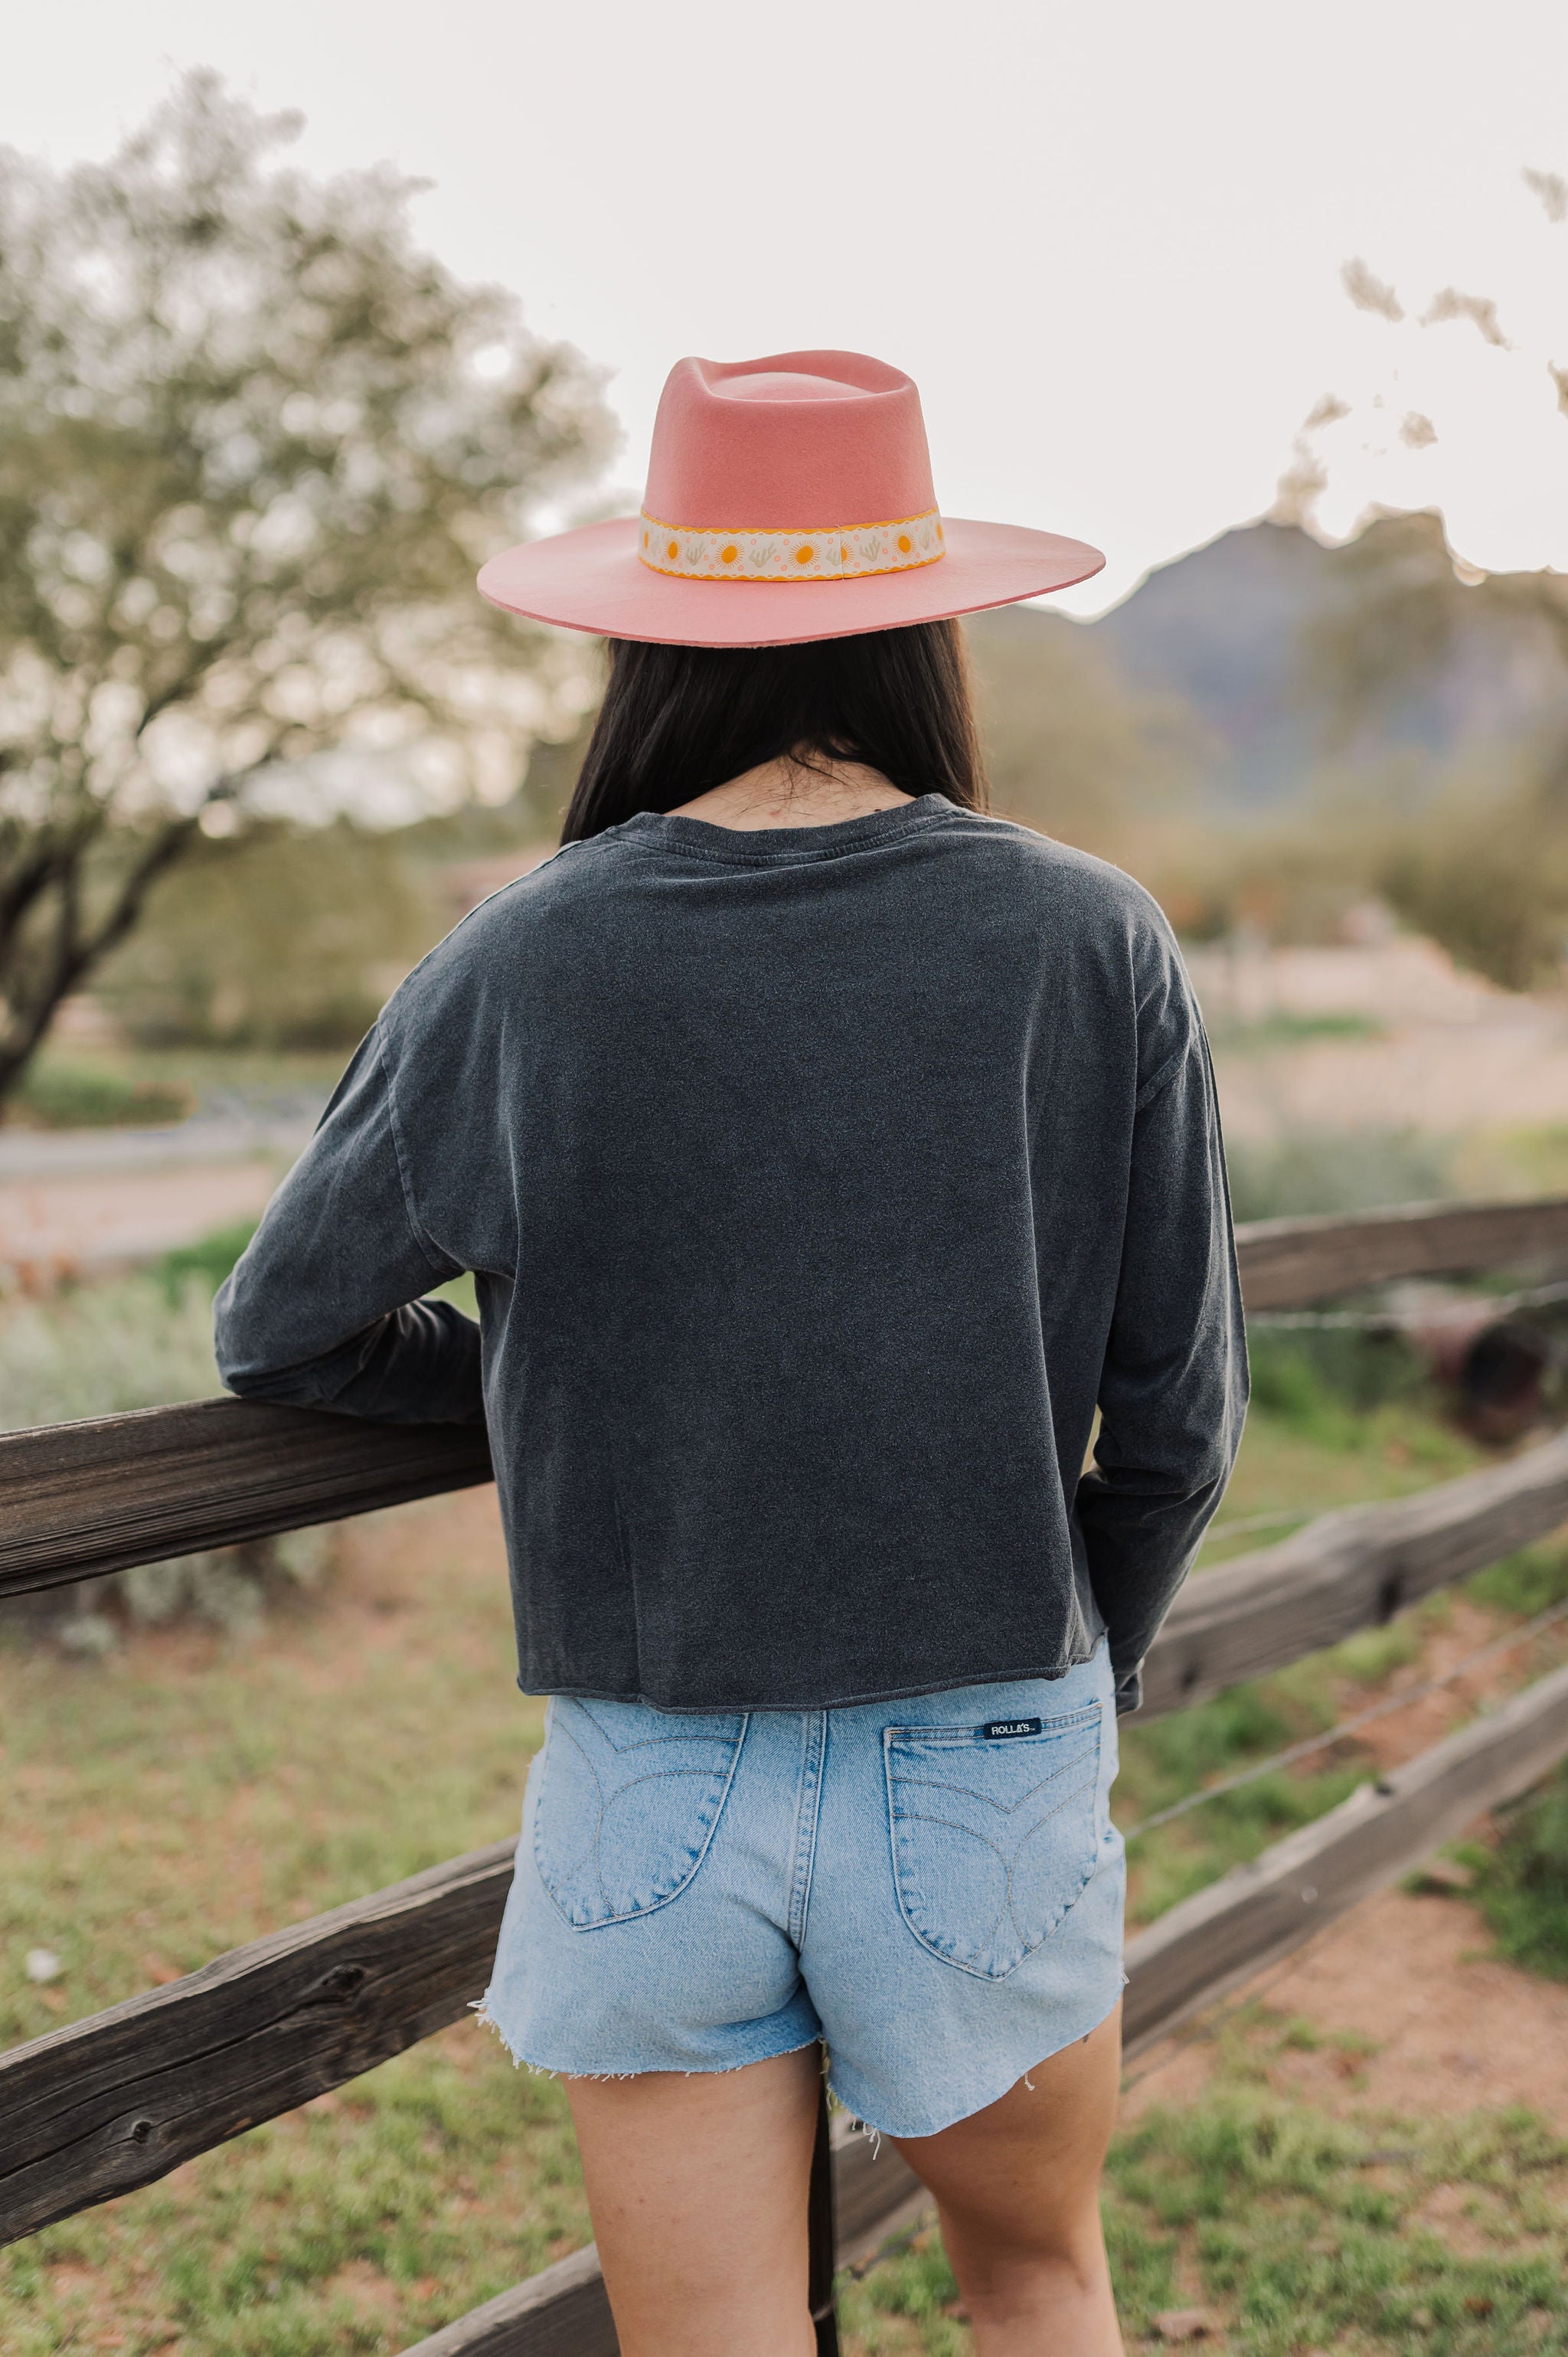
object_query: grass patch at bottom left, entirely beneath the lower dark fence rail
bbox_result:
[0,2032,590,2357]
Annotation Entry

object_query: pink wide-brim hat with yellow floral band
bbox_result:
[479,351,1106,646]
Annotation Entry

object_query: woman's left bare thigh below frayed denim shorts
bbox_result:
[566,2046,821,2357]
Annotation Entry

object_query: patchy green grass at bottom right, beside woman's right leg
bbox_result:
[839,2093,1568,2357]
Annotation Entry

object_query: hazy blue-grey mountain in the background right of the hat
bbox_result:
[969,521,1563,809]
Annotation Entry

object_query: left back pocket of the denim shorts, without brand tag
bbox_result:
[533,1695,745,1930]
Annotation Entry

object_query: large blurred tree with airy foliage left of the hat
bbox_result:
[0,75,611,1098]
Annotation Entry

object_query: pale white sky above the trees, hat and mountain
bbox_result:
[0,0,1568,613]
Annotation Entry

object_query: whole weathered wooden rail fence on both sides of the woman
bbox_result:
[0,1200,1568,2357]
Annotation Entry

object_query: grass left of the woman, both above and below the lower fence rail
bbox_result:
[0,1492,587,2357]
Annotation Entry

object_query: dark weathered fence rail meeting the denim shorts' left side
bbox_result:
[0,1841,514,2241]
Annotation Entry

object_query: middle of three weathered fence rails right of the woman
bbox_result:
[1144,1433,1568,1716]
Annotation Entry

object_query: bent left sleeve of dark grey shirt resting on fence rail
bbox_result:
[214,1023,483,1424]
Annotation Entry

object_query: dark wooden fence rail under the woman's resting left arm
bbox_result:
[0,1398,493,1596]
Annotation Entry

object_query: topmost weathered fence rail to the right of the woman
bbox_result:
[1236,1195,1568,1310]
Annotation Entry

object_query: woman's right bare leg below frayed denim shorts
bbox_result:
[896,2006,1122,2357]
